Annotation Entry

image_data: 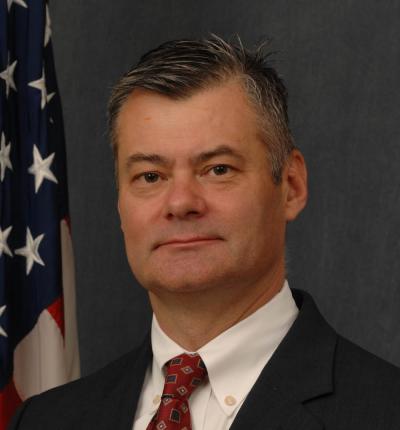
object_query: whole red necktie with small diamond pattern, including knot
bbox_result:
[147,354,207,430]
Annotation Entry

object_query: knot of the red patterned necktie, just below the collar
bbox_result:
[162,353,207,399]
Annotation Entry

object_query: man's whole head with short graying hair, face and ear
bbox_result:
[110,38,307,306]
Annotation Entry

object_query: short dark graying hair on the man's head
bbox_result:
[108,35,294,184]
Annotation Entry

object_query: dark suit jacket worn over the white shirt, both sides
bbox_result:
[10,290,400,430]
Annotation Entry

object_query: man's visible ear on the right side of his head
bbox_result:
[282,149,308,221]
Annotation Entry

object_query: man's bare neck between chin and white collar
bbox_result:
[149,265,285,352]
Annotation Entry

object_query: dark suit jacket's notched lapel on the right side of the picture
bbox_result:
[231,290,337,430]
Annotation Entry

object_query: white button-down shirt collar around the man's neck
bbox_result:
[151,281,298,415]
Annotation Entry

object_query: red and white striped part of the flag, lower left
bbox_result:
[0,220,80,429]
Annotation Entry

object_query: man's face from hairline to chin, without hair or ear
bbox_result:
[117,81,294,293]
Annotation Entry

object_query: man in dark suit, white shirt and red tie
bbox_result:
[11,36,400,430]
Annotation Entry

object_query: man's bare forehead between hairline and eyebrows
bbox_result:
[116,80,259,159]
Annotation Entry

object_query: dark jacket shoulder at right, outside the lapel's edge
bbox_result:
[309,335,400,430]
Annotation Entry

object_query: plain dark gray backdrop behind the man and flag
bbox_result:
[50,0,400,374]
